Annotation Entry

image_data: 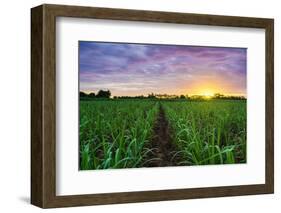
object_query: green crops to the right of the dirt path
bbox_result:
[163,100,246,165]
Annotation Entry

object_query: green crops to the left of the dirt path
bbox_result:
[79,100,159,170]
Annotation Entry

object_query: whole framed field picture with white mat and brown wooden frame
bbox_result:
[31,5,274,208]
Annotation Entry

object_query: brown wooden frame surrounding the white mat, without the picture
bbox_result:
[31,5,274,208]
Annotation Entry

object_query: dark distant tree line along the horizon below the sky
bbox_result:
[80,90,246,100]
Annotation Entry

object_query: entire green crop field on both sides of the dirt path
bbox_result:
[80,99,246,170]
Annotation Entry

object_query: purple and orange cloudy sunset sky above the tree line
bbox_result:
[79,41,247,96]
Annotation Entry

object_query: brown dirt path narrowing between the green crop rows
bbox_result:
[145,104,178,167]
